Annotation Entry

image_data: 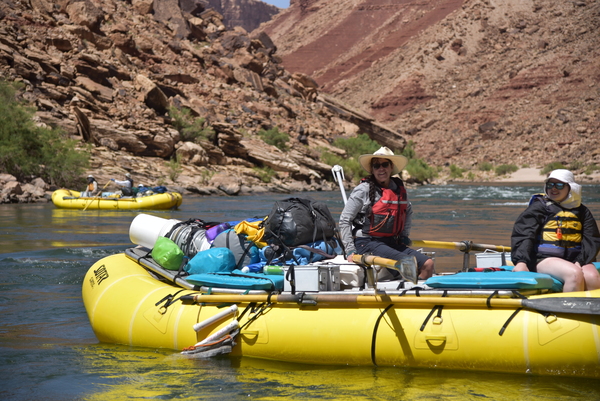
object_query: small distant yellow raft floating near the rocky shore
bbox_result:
[52,189,182,210]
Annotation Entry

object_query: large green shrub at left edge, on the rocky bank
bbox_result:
[0,80,89,187]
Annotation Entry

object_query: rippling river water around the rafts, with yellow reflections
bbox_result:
[0,184,600,401]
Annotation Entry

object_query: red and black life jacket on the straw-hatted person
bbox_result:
[362,177,408,237]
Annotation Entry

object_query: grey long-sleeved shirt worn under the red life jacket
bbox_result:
[339,180,412,255]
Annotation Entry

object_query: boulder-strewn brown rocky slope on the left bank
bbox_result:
[0,0,406,201]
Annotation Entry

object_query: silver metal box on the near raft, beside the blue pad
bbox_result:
[283,265,340,292]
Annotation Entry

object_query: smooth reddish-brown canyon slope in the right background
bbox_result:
[259,0,600,179]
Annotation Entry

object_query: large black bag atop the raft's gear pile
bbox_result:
[263,198,337,247]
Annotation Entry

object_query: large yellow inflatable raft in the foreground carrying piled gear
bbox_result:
[82,248,600,378]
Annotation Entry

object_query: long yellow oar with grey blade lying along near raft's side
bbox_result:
[181,293,600,315]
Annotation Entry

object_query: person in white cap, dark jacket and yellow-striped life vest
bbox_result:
[511,169,600,292]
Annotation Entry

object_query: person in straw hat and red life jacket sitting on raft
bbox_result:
[339,147,434,281]
